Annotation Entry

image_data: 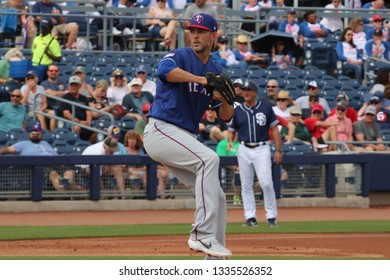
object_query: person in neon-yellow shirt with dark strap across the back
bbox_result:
[31,18,62,68]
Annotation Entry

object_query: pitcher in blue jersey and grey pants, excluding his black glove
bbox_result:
[144,13,233,259]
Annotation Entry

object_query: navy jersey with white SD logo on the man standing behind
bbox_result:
[229,101,279,143]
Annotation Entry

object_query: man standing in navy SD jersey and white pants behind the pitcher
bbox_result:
[228,80,282,227]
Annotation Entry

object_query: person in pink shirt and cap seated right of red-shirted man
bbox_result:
[326,100,353,150]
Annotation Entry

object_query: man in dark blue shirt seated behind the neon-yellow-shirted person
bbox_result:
[32,0,79,49]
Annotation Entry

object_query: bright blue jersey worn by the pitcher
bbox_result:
[148,48,221,134]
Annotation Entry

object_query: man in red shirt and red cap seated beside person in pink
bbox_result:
[304,104,337,151]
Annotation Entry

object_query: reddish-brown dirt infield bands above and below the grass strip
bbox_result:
[0,207,390,259]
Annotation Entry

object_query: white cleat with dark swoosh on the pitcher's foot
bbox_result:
[188,237,232,257]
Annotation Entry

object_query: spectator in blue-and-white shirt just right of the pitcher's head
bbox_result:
[212,36,248,69]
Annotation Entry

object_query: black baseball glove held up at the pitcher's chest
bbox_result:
[206,72,236,105]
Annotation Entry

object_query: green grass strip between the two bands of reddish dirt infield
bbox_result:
[0,220,390,241]
